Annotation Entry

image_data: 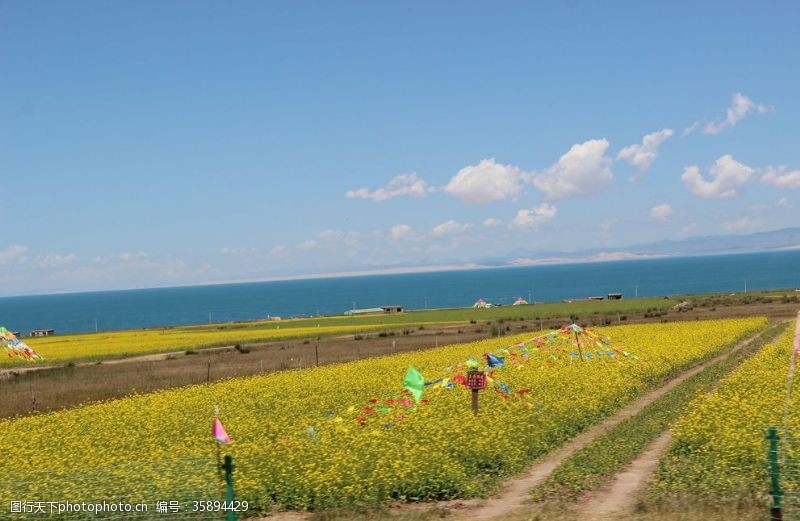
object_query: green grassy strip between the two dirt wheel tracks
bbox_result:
[532,324,785,501]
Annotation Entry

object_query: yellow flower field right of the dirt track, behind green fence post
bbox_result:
[651,316,800,503]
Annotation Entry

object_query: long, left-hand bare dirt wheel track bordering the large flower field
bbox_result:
[458,331,764,520]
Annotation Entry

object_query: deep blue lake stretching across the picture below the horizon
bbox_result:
[0,250,800,334]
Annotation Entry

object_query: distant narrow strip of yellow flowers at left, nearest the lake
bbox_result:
[0,323,396,365]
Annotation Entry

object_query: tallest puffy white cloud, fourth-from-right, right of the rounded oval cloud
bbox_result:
[533,139,614,199]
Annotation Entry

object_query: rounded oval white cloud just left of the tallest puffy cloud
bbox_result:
[444,158,529,204]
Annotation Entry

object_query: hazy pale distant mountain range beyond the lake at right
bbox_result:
[476,227,800,266]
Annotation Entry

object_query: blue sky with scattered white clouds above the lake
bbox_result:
[0,1,800,294]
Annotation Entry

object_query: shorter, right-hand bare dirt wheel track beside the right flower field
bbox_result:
[573,431,672,521]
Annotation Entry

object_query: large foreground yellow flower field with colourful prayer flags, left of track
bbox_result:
[0,318,766,509]
